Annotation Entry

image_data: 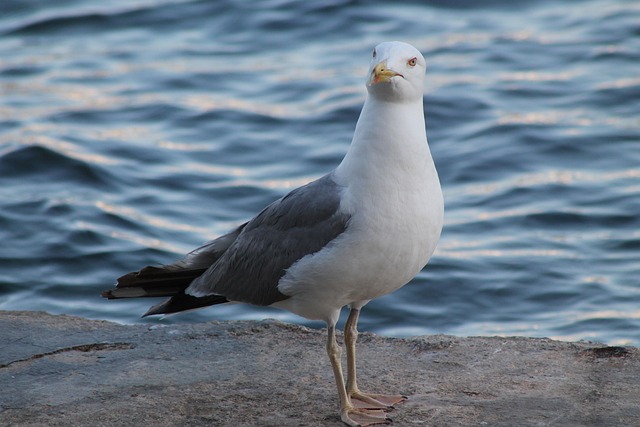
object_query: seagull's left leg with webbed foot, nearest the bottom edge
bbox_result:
[327,325,391,427]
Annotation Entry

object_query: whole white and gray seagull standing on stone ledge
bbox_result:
[102,42,444,426]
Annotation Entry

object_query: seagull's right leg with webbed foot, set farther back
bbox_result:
[344,308,406,411]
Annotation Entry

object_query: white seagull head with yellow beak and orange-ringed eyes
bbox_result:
[367,42,426,101]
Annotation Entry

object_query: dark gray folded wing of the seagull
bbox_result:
[186,174,349,305]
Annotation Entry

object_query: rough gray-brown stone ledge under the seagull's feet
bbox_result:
[0,312,640,426]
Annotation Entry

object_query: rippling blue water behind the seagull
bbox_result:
[0,0,640,345]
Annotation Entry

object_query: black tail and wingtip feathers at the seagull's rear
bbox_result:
[102,266,228,317]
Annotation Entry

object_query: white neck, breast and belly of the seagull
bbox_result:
[278,95,443,320]
